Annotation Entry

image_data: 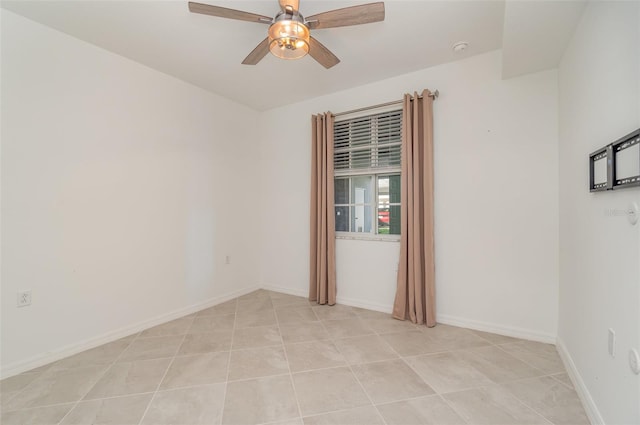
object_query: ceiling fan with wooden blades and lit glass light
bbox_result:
[189,0,384,69]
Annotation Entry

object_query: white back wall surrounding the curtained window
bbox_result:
[260,52,558,341]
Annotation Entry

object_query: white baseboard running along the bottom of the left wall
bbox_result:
[0,285,259,379]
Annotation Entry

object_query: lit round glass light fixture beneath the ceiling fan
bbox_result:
[269,19,309,59]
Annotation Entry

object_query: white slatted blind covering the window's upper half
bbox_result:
[333,110,402,176]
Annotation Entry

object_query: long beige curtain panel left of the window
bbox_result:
[309,113,336,305]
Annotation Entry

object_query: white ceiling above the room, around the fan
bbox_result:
[2,0,584,110]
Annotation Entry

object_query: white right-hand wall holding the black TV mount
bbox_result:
[558,2,640,424]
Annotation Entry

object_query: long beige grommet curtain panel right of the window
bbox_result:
[393,90,436,327]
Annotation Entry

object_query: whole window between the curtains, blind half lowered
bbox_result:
[334,110,402,235]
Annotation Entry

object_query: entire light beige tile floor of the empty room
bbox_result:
[0,290,589,425]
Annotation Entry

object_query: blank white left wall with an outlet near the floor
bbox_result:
[1,10,259,375]
